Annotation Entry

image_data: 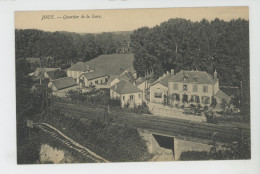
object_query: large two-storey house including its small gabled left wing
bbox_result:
[150,70,231,109]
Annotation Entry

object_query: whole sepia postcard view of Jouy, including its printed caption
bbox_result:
[13,6,251,165]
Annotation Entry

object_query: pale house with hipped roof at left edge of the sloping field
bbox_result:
[67,62,94,84]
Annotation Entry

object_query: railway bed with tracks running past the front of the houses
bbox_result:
[51,102,250,144]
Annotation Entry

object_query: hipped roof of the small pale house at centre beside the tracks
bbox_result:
[110,80,142,94]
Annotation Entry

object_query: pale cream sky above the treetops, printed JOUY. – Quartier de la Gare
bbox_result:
[15,6,249,33]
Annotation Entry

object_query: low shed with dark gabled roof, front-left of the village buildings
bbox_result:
[48,77,78,97]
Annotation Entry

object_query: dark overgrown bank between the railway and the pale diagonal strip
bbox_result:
[38,110,151,162]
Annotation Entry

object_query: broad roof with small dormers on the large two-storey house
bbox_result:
[169,70,217,84]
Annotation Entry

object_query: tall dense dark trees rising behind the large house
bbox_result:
[131,18,249,86]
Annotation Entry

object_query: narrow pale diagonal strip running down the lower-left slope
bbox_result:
[34,123,109,163]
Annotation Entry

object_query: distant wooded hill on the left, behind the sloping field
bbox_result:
[15,29,131,63]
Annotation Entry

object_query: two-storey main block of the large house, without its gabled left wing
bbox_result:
[168,70,230,106]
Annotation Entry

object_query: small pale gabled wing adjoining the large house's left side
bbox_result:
[150,70,174,103]
